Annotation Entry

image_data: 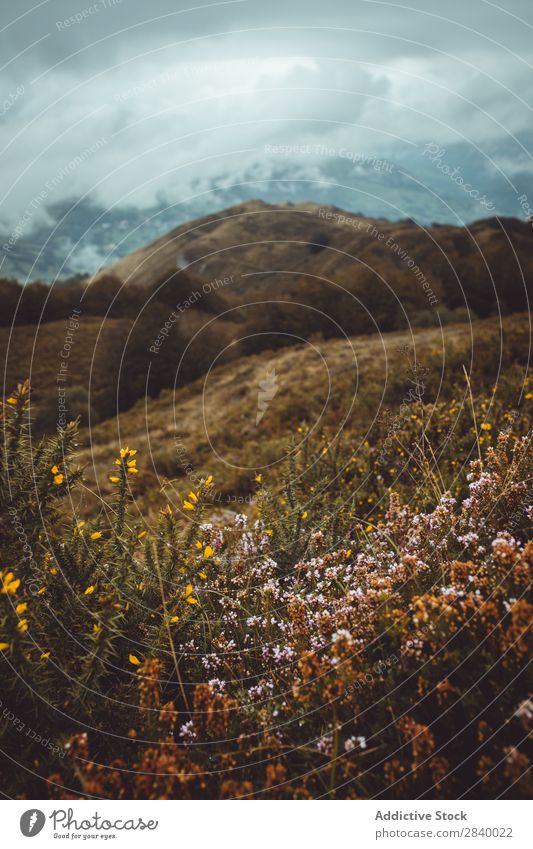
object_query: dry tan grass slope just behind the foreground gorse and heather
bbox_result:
[74,316,528,507]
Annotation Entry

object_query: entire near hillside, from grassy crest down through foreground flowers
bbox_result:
[0,308,533,803]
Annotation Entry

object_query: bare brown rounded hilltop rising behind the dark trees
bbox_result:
[92,201,533,315]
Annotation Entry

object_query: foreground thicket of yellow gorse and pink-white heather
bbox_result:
[0,384,533,799]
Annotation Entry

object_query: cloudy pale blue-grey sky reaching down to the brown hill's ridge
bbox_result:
[0,0,533,274]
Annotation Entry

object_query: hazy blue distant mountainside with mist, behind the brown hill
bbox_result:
[0,143,533,282]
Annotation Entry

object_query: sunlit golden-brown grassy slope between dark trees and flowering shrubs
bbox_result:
[74,315,530,511]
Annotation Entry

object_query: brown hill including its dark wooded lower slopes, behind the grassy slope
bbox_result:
[0,200,533,430]
